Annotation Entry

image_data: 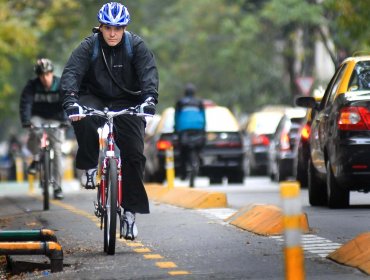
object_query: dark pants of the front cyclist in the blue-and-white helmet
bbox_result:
[73,96,149,214]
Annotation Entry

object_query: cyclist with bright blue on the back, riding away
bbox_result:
[174,83,206,180]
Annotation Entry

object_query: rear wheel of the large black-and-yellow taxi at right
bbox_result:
[326,161,349,208]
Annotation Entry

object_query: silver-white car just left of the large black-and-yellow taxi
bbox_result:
[268,108,306,182]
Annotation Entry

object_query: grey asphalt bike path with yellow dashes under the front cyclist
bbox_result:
[2,191,363,279]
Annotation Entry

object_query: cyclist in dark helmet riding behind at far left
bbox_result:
[19,58,68,199]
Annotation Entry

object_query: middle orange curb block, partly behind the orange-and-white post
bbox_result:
[225,204,310,235]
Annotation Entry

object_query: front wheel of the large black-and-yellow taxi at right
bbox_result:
[307,159,327,206]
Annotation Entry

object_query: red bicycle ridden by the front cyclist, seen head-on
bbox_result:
[82,106,152,255]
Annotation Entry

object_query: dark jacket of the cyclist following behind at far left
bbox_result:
[19,76,67,124]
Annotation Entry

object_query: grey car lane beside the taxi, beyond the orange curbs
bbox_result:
[202,176,370,243]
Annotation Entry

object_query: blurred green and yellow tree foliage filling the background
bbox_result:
[0,0,370,140]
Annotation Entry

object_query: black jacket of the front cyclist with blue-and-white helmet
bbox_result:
[61,33,158,108]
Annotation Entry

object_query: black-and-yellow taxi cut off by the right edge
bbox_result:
[296,56,370,208]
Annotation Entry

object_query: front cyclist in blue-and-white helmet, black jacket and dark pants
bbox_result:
[62,2,158,240]
